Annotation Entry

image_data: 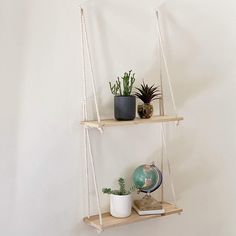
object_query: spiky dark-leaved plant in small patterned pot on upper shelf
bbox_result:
[135,81,161,119]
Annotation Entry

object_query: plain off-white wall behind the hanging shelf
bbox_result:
[0,0,236,236]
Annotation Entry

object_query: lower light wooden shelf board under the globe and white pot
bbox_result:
[84,202,183,231]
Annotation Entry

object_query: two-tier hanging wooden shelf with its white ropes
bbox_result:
[80,3,183,232]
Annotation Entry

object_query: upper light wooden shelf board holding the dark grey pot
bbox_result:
[81,116,184,128]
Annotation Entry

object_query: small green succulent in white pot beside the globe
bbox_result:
[102,178,135,218]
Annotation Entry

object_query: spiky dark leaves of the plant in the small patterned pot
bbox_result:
[134,81,161,104]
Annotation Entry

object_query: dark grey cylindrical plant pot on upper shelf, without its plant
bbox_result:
[114,95,136,120]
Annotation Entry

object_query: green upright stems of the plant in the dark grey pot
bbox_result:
[109,70,135,96]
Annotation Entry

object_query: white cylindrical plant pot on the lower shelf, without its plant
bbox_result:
[110,194,132,218]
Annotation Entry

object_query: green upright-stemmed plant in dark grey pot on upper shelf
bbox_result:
[109,70,136,121]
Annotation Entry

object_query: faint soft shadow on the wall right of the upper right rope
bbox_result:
[162,3,228,108]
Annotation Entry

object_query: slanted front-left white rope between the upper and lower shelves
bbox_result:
[86,129,102,225]
